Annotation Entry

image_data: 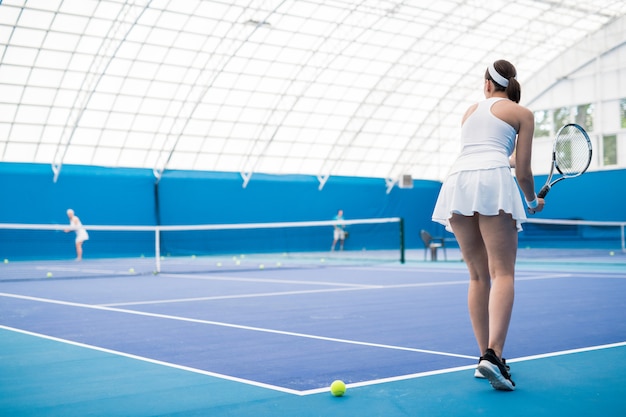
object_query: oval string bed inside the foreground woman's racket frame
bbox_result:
[554,127,591,176]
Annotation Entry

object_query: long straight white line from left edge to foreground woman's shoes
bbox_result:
[0,293,478,359]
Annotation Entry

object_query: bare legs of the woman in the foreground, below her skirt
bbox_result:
[450,212,517,358]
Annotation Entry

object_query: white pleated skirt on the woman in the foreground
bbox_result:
[432,167,526,232]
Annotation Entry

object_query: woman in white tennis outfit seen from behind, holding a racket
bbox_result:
[433,60,544,391]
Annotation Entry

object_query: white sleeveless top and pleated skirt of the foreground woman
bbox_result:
[432,97,526,232]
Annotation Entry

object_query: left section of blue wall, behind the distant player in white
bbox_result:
[0,163,155,259]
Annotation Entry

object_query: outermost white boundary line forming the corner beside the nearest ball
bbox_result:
[0,325,626,396]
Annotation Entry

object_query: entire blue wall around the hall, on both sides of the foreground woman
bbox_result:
[0,163,626,258]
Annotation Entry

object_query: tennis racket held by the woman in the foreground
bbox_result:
[537,123,592,198]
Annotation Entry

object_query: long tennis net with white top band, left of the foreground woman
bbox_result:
[0,217,405,281]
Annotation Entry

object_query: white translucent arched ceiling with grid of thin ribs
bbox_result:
[0,0,626,183]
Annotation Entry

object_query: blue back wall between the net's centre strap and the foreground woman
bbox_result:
[159,171,440,253]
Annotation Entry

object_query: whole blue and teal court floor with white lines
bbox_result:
[0,250,626,417]
